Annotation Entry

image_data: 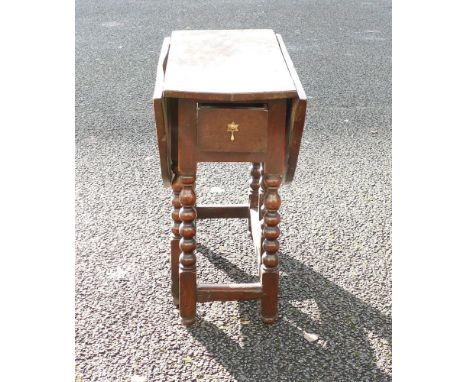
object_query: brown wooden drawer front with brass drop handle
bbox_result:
[197,104,268,153]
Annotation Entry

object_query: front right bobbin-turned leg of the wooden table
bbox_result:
[261,174,281,324]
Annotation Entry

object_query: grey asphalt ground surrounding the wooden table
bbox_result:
[76,0,392,382]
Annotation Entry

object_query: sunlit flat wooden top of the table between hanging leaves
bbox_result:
[163,29,297,101]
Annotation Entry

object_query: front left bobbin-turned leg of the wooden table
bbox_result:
[179,175,197,325]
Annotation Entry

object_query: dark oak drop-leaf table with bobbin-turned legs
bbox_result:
[153,29,307,325]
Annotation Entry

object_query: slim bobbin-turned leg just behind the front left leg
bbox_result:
[171,173,182,305]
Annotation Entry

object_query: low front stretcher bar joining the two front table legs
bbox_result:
[197,283,263,302]
